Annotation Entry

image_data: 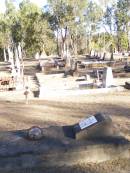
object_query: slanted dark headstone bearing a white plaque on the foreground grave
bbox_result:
[73,113,117,140]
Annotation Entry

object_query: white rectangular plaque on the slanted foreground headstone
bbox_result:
[79,116,98,129]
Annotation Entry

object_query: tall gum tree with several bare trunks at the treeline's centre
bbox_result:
[48,0,87,58]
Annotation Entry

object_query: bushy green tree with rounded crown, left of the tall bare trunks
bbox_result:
[19,0,55,56]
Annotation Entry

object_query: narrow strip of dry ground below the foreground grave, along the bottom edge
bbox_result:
[8,159,130,173]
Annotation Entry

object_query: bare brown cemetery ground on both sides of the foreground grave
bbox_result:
[0,59,130,173]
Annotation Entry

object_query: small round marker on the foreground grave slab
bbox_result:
[28,126,42,140]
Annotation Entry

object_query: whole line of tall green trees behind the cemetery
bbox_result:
[0,0,130,59]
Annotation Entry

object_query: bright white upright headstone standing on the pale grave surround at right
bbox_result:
[103,67,114,88]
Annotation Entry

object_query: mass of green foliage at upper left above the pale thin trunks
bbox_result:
[0,0,56,57]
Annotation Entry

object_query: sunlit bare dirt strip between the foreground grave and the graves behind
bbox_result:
[0,91,130,139]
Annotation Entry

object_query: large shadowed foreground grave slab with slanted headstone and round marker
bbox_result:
[0,113,130,172]
